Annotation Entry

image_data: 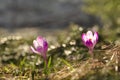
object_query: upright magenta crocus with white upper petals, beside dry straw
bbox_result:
[82,31,98,53]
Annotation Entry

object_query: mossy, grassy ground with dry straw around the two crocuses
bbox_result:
[0,24,120,80]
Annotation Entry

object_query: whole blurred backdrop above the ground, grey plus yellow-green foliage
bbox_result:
[0,0,120,36]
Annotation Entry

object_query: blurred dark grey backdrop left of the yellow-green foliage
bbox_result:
[0,0,102,32]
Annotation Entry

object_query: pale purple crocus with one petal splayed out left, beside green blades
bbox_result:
[30,36,48,64]
